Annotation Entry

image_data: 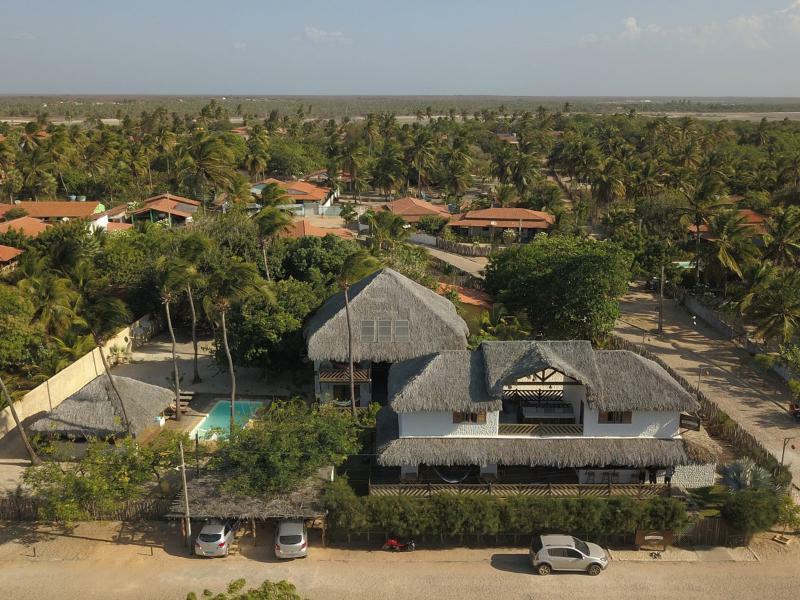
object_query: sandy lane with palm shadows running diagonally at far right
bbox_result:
[615,290,800,488]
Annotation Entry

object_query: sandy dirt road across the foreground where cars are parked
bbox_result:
[0,523,800,600]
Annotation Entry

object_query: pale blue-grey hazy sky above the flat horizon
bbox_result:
[0,0,800,97]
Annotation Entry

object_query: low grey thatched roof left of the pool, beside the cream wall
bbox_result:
[31,374,175,438]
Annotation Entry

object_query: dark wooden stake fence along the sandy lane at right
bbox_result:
[609,334,792,485]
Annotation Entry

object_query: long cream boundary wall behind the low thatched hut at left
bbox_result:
[0,315,161,438]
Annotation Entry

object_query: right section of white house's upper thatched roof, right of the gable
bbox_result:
[594,350,700,412]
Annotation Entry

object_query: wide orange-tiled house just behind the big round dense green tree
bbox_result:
[450,208,556,242]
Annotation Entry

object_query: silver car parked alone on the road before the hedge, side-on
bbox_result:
[530,535,608,575]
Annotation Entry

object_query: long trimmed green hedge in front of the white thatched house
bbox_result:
[325,479,688,537]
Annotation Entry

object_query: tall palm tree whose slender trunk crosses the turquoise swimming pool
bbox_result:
[203,257,272,438]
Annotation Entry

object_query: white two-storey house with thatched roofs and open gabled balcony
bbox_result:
[377,341,716,487]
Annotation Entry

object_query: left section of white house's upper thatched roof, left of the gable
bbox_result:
[389,350,502,412]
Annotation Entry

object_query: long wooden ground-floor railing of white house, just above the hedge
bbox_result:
[369,483,669,499]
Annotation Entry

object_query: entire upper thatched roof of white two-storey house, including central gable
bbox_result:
[389,340,699,413]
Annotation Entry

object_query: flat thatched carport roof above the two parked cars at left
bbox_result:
[167,467,330,521]
